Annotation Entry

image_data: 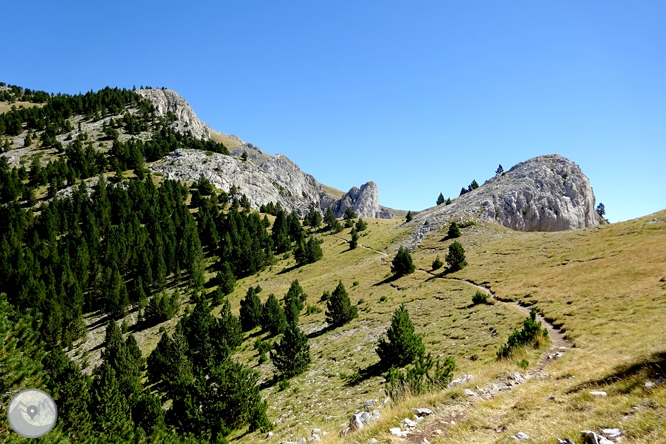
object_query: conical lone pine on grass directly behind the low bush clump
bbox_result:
[375,304,425,368]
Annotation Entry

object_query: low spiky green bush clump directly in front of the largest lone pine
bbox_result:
[384,354,456,401]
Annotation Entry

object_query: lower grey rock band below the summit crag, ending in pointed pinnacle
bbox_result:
[151,149,391,218]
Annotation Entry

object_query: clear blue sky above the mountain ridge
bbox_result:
[0,0,666,222]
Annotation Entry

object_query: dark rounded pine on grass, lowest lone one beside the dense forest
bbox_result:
[271,324,311,378]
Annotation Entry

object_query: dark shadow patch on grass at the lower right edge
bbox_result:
[567,351,666,393]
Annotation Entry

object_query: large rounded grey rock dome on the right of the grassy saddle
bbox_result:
[408,154,599,247]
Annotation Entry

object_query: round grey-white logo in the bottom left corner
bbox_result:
[7,389,58,438]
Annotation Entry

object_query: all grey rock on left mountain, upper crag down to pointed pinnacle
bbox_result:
[136,89,392,219]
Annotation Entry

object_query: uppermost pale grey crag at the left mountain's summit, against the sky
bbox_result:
[136,89,211,139]
